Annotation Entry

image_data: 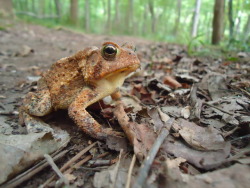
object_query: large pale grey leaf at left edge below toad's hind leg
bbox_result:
[0,129,69,183]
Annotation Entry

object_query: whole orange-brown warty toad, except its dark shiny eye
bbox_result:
[19,42,140,140]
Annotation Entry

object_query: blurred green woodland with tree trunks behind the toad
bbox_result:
[0,0,250,52]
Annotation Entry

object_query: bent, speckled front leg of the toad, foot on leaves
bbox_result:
[69,88,123,140]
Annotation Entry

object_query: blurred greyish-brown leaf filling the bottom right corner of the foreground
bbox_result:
[164,161,250,188]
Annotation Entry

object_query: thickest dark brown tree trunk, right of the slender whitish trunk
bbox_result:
[212,0,225,45]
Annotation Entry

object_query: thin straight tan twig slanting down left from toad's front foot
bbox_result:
[43,142,97,186]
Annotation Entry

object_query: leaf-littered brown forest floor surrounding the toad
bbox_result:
[0,21,250,187]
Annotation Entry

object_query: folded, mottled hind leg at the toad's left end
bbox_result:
[19,80,52,132]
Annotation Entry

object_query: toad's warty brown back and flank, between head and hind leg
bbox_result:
[43,53,85,109]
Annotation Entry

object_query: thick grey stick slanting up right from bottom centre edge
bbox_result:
[132,127,169,188]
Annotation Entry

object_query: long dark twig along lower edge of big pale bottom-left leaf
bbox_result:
[0,150,68,188]
